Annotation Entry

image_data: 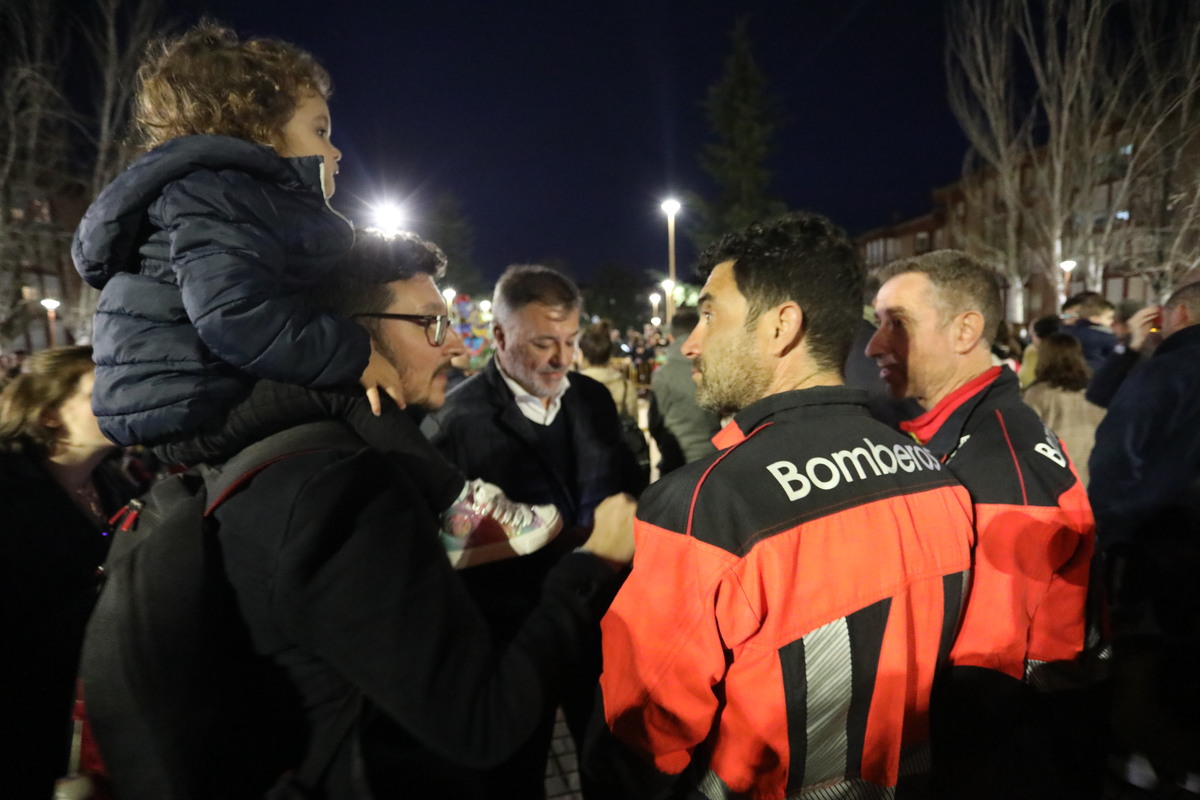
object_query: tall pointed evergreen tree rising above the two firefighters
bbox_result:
[689,18,787,247]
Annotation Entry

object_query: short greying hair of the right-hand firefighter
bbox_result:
[880,249,1004,344]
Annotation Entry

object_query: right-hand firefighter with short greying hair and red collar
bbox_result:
[866,251,1103,798]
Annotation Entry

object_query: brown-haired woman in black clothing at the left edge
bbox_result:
[0,347,133,798]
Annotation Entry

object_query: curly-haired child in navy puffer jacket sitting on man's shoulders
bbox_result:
[72,22,562,560]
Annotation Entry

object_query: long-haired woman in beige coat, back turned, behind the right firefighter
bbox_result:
[1024,333,1104,486]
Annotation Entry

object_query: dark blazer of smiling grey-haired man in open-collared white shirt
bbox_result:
[422,359,646,528]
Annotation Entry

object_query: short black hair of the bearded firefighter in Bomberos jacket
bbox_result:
[700,211,865,372]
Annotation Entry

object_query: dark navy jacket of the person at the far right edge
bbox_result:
[1088,325,1200,549]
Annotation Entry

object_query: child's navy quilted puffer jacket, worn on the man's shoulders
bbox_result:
[71,136,371,445]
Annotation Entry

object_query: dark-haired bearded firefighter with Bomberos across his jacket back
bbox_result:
[584,215,973,799]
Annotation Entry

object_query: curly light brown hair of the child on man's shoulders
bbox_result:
[134,19,332,150]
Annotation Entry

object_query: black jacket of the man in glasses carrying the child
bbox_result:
[181,398,612,799]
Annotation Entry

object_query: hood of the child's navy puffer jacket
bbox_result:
[71,136,322,289]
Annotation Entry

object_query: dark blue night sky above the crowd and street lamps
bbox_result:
[180,0,966,281]
